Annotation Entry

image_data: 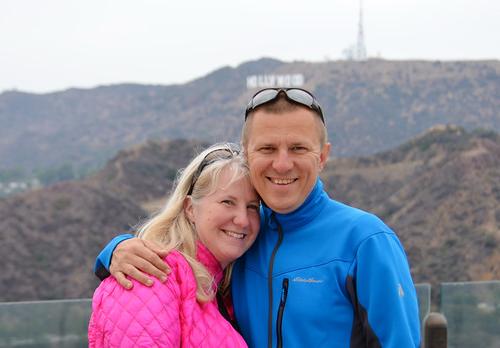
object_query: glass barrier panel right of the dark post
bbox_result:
[441,281,500,348]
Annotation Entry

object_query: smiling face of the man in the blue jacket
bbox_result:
[245,108,330,214]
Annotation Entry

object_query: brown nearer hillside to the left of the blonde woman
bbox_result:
[0,140,203,301]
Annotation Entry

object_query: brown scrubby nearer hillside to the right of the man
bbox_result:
[323,126,500,290]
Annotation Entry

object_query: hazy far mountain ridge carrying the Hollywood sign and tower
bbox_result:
[0,59,500,177]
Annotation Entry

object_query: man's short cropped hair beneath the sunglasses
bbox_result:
[241,93,328,151]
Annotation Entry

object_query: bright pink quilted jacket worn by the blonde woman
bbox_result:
[89,244,247,348]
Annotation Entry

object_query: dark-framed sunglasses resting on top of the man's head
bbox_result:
[245,88,325,124]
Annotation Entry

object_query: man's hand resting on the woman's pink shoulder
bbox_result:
[109,238,170,289]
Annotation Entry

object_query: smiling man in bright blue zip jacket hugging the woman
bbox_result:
[97,89,420,348]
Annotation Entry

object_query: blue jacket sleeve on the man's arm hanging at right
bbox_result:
[354,231,420,348]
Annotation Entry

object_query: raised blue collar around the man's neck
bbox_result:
[262,178,328,232]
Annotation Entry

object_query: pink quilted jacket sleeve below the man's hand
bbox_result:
[88,264,181,348]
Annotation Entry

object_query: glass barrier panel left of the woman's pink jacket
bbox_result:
[0,299,92,348]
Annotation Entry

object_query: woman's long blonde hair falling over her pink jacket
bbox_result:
[137,143,249,302]
